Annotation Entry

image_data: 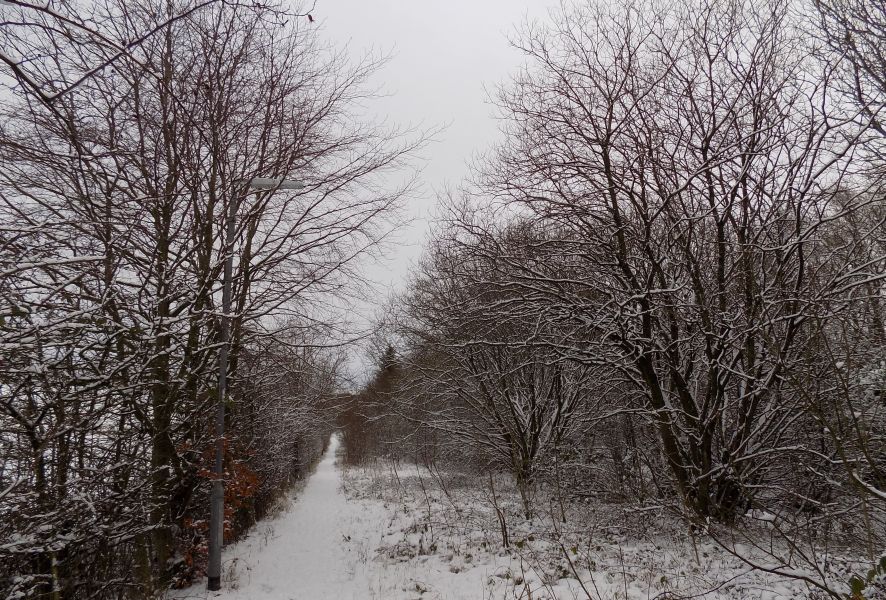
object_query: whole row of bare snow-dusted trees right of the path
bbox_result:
[344,0,886,597]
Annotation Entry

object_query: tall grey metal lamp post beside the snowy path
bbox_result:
[206,177,305,592]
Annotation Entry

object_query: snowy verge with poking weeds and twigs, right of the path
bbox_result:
[336,462,824,600]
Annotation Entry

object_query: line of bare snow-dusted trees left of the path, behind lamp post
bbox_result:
[0,0,414,599]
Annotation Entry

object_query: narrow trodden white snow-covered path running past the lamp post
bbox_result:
[174,436,385,600]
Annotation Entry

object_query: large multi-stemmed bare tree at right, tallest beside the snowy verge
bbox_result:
[476,3,876,521]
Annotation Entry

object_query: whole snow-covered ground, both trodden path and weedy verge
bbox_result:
[172,438,876,600]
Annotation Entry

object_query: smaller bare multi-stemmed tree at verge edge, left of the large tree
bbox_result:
[402,218,598,518]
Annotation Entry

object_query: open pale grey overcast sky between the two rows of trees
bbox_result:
[313,0,554,290]
